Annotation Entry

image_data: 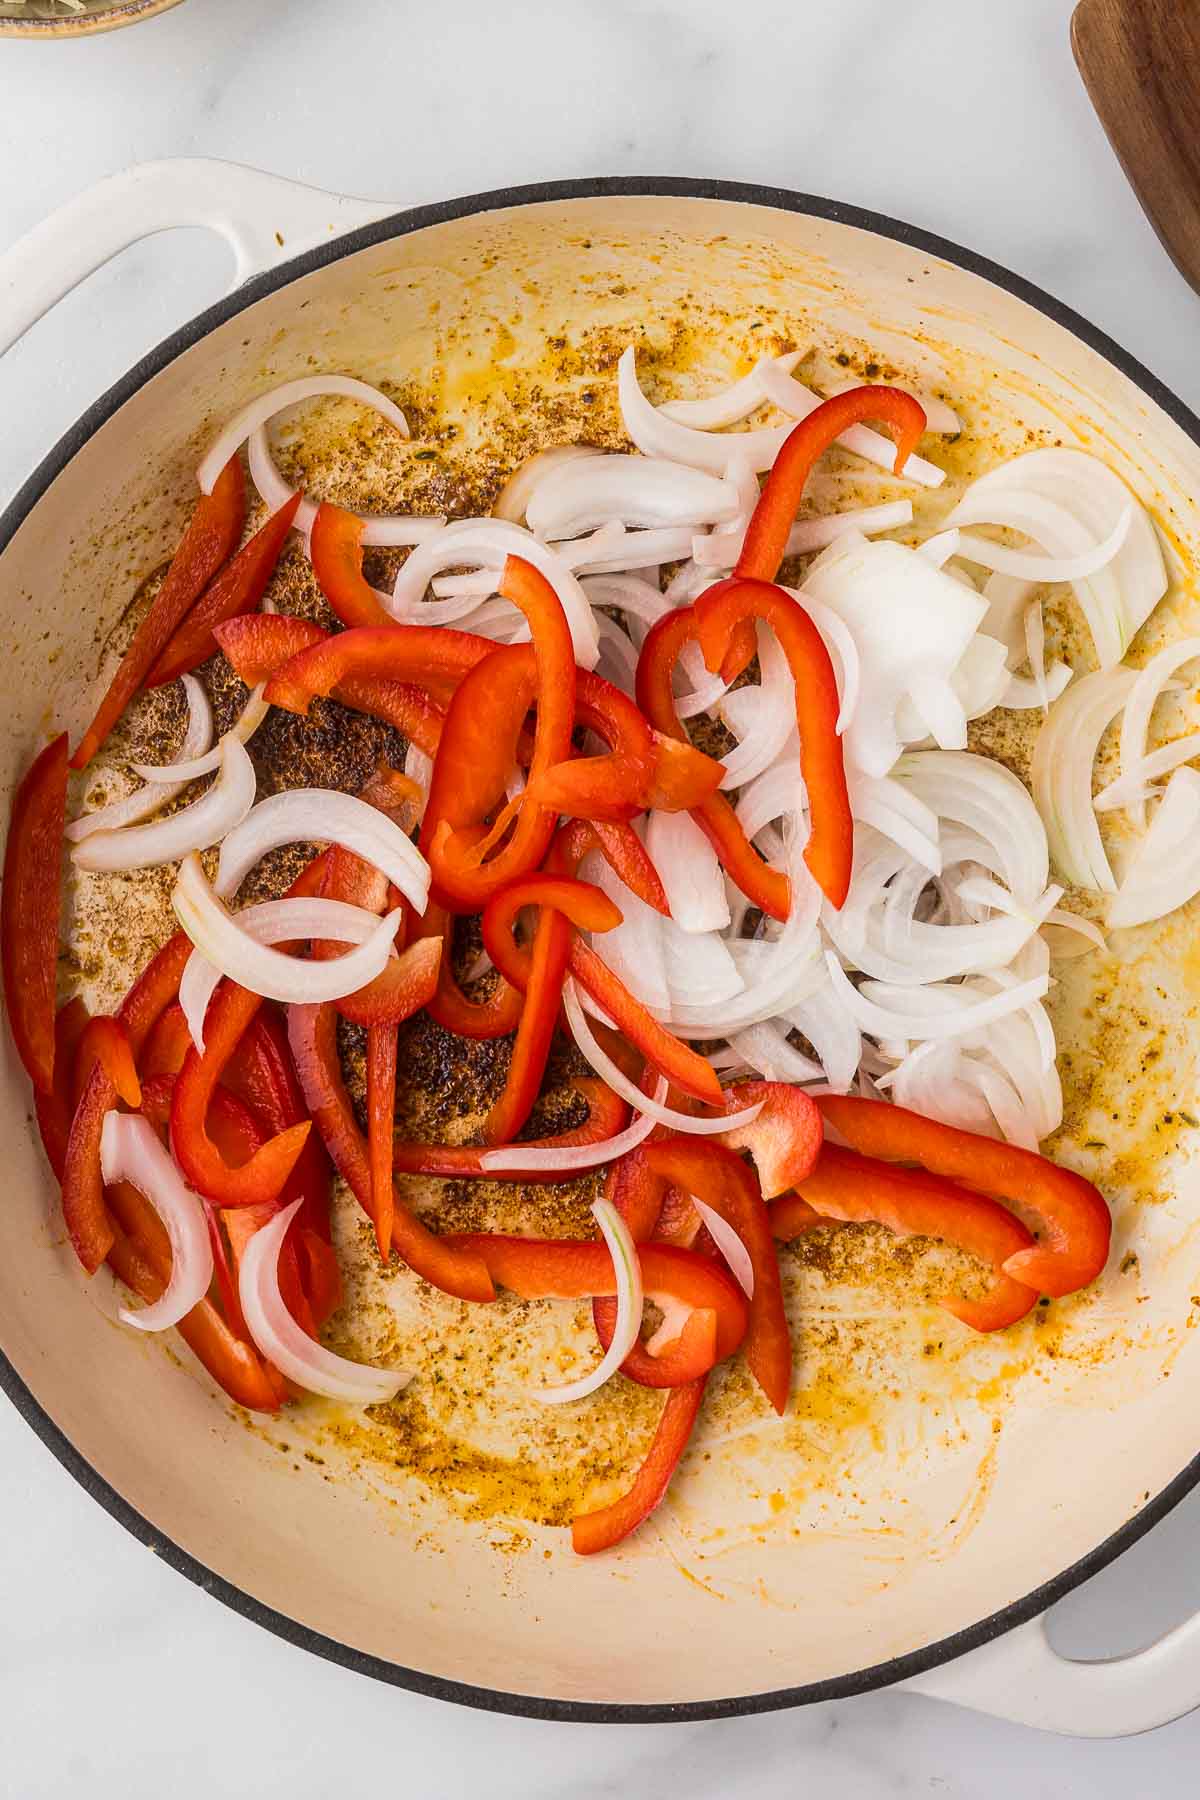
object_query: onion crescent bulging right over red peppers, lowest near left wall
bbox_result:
[101,1112,212,1332]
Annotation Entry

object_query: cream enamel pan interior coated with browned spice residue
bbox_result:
[0,196,1200,1705]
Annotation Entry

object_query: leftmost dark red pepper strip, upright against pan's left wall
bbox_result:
[0,734,67,1094]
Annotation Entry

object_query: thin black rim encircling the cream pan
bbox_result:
[0,175,1200,1724]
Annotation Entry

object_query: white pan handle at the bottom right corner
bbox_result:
[901,1613,1200,1737]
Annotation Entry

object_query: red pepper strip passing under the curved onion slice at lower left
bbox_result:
[108,1181,286,1413]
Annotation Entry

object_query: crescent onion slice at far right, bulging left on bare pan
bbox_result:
[1031,670,1137,893]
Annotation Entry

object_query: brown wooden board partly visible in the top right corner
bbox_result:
[1070,0,1200,293]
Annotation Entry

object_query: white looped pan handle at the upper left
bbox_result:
[0,157,396,355]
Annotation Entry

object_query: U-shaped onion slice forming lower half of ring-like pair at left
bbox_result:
[171,851,403,1006]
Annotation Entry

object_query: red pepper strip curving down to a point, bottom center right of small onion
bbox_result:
[644,1136,792,1413]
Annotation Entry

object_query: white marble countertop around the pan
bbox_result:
[0,0,1200,1800]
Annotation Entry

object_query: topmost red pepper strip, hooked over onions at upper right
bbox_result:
[734,387,925,581]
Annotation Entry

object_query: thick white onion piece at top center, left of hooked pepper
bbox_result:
[525,455,738,542]
